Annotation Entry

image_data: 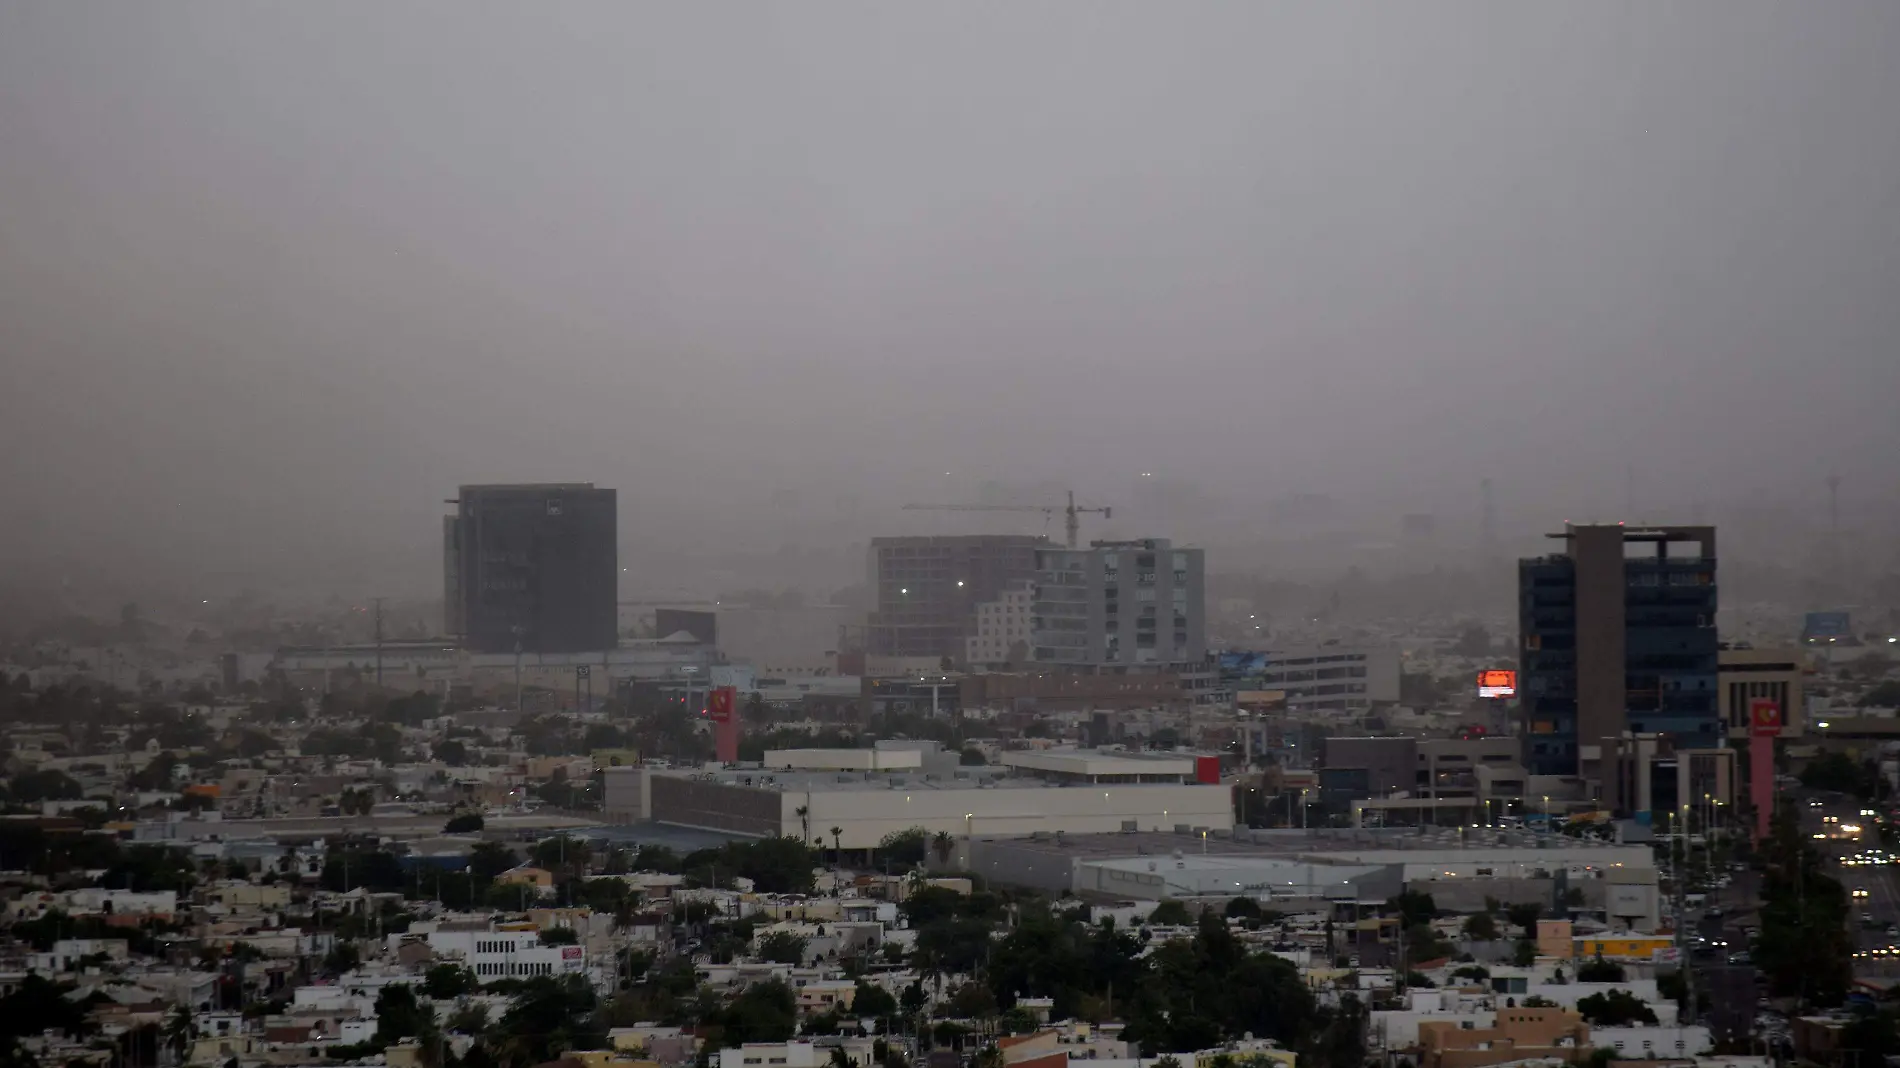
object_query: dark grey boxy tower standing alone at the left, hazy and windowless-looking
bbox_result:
[443,483,619,652]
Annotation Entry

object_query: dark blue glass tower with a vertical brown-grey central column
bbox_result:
[1518,524,1723,777]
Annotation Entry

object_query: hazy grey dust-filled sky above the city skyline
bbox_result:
[0,0,1900,587]
